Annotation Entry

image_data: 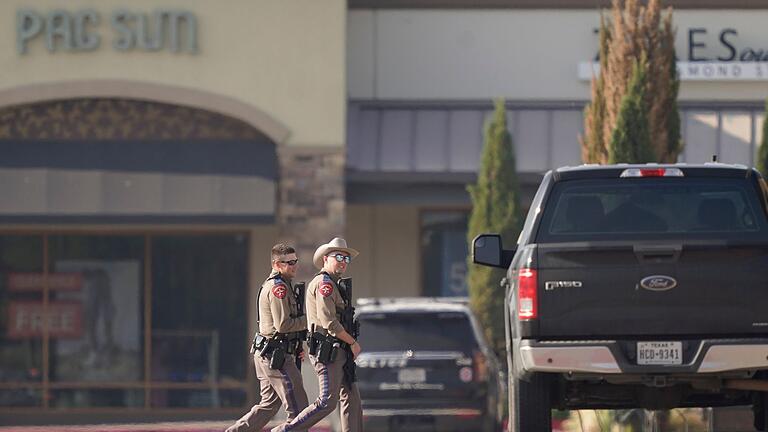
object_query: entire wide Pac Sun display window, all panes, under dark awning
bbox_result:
[0,233,249,410]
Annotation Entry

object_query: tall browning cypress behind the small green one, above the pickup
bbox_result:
[580,0,682,163]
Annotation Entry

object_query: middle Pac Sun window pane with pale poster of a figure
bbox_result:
[49,235,144,408]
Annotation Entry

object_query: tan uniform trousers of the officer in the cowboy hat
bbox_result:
[272,350,363,432]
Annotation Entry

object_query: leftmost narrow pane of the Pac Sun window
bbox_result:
[0,235,43,407]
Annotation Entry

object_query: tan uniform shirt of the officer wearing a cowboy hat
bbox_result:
[307,273,344,337]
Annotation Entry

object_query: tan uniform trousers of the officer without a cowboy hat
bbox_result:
[226,354,309,432]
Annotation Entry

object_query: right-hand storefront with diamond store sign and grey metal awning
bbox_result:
[347,0,768,296]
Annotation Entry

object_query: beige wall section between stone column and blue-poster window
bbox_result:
[346,205,422,298]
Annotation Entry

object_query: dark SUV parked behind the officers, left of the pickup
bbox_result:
[356,298,504,431]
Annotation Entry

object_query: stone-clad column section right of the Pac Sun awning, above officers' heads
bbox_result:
[277,146,346,281]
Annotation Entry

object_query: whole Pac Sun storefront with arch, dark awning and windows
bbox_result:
[0,0,346,424]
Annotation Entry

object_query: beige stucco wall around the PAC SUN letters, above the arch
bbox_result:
[0,0,346,146]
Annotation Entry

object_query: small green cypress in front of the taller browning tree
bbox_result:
[608,58,655,163]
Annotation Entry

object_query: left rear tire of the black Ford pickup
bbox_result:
[509,373,552,432]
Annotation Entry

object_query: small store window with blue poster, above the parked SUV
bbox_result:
[421,210,469,297]
